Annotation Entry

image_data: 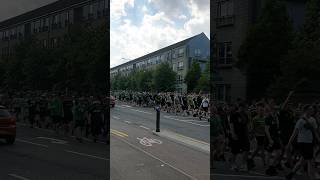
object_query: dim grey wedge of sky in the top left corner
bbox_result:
[0,0,57,22]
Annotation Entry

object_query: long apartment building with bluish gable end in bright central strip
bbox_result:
[110,33,210,92]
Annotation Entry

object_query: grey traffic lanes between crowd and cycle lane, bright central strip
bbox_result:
[111,101,210,143]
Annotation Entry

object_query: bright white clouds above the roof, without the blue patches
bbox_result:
[110,0,210,67]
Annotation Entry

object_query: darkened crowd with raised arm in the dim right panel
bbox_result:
[211,91,320,180]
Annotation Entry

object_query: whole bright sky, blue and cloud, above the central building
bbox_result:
[110,0,210,68]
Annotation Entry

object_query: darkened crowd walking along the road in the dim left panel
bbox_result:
[0,91,109,143]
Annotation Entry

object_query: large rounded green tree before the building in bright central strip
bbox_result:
[153,63,177,92]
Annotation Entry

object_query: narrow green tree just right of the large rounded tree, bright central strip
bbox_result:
[185,60,201,92]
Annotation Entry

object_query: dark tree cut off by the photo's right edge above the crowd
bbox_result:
[270,0,320,97]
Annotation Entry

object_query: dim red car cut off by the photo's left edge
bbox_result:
[0,106,17,144]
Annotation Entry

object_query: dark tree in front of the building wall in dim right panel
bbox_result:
[237,0,293,99]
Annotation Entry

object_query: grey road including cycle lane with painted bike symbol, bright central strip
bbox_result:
[110,103,210,180]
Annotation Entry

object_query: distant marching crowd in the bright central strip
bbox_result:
[112,91,210,121]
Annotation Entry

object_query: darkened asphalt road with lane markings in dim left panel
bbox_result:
[0,125,109,180]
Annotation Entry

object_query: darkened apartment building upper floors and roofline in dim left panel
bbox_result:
[0,0,109,59]
